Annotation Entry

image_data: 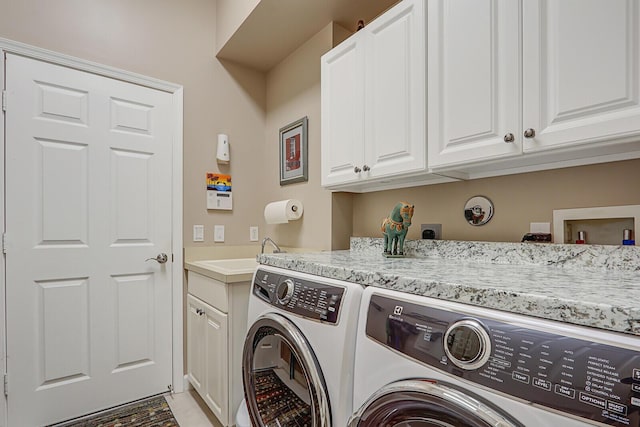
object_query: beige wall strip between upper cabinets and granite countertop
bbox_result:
[353,160,640,242]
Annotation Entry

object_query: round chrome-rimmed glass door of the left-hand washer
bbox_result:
[242,313,331,427]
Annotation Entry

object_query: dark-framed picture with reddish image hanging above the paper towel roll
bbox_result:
[280,116,309,186]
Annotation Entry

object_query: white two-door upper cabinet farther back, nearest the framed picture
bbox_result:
[321,0,438,191]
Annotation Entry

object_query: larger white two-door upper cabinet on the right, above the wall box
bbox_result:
[427,0,640,177]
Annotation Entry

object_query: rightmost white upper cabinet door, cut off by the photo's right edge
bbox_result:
[523,0,640,152]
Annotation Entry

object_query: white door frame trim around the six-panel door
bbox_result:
[0,38,185,427]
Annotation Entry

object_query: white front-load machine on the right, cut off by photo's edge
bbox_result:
[348,288,640,427]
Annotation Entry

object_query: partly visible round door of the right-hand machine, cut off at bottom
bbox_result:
[349,380,523,427]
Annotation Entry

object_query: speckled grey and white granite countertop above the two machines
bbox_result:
[258,238,640,335]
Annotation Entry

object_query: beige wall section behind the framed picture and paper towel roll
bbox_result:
[256,25,333,249]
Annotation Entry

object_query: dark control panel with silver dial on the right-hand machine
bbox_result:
[366,294,640,426]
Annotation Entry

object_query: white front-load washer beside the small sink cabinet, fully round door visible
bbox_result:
[236,266,363,427]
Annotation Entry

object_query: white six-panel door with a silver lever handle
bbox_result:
[5,54,172,426]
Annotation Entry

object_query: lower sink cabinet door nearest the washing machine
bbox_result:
[203,305,229,426]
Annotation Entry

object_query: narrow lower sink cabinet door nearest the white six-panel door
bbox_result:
[187,295,206,393]
